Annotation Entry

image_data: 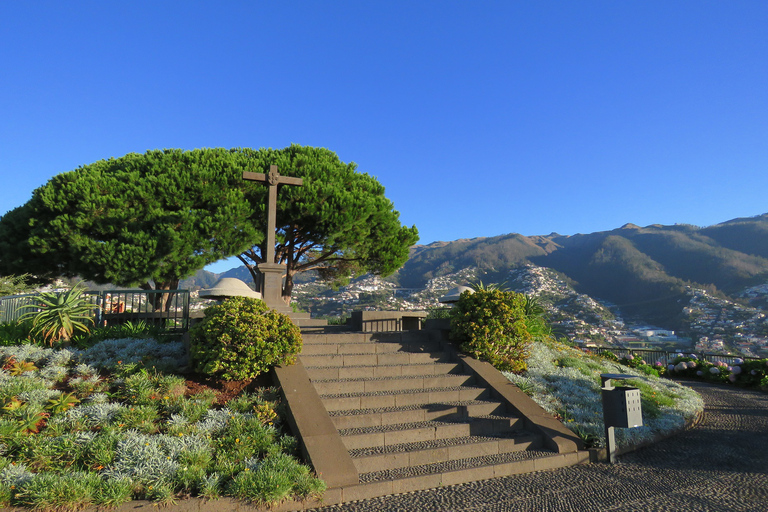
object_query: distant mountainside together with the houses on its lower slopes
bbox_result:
[183,214,768,358]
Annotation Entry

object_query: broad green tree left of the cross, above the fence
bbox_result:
[0,149,263,308]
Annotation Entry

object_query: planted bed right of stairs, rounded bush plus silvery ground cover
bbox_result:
[451,287,703,452]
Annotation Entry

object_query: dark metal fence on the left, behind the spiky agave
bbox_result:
[0,290,189,331]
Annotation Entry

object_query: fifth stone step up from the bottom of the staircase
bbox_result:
[320,386,489,412]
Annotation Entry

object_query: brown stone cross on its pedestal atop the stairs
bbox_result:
[243,165,304,313]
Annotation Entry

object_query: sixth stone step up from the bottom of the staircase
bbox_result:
[312,374,475,395]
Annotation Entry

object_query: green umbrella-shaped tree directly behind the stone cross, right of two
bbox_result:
[234,144,419,301]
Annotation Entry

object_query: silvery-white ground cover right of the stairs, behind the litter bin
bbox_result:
[504,342,704,447]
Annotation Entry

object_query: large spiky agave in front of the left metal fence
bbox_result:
[19,283,96,345]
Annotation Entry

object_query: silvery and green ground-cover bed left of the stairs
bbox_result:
[0,339,324,510]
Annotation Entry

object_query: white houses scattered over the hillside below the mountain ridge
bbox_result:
[294,264,768,356]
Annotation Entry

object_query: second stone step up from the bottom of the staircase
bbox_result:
[350,431,541,473]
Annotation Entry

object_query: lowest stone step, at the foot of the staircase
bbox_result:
[344,450,589,502]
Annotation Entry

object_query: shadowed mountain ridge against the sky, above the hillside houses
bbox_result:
[184,213,768,328]
